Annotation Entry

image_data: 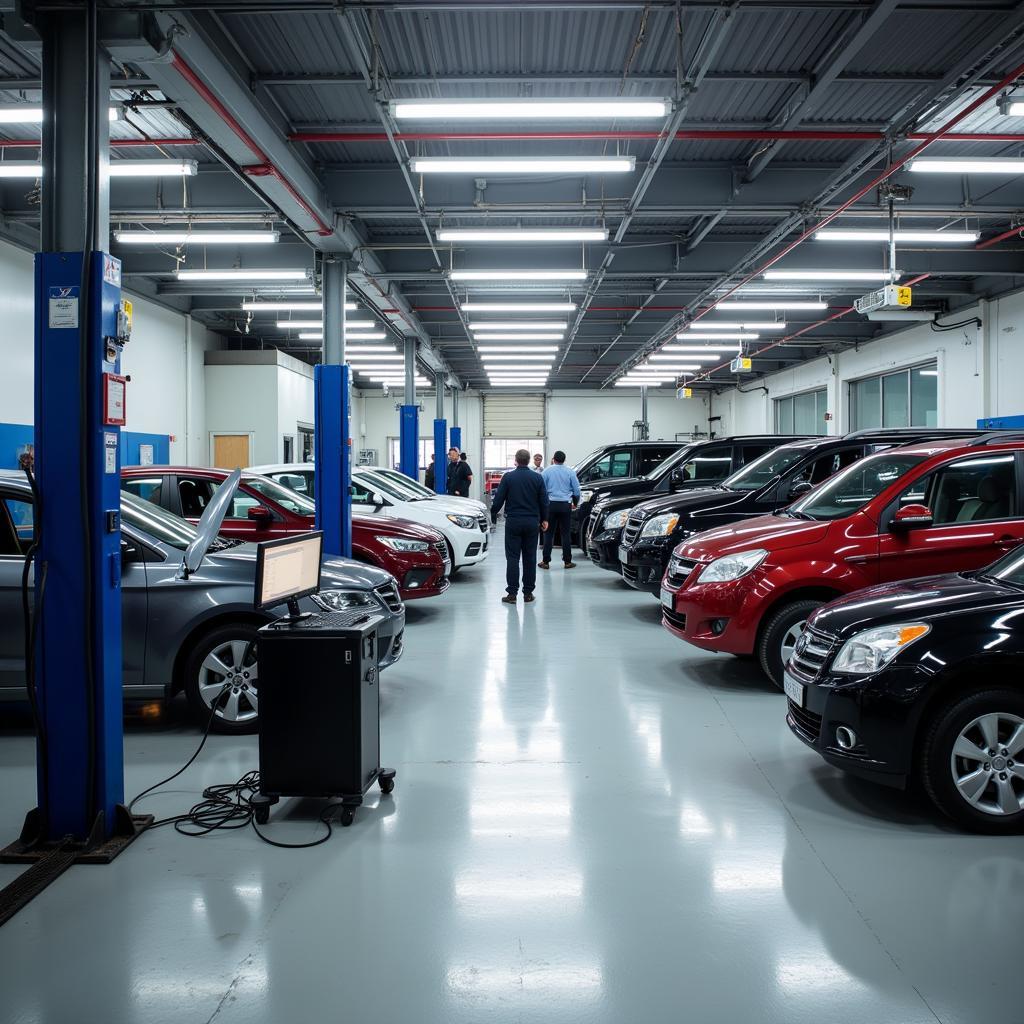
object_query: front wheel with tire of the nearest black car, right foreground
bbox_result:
[919,688,1024,836]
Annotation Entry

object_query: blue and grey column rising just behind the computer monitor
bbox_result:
[313,253,352,558]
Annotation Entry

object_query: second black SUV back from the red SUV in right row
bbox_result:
[580,434,805,572]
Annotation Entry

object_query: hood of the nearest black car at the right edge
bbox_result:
[812,572,1024,636]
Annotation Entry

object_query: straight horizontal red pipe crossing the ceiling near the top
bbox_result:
[288,128,1024,142]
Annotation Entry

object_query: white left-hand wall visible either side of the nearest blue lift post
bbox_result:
[0,234,220,464]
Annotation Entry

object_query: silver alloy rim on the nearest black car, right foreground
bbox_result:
[949,712,1024,816]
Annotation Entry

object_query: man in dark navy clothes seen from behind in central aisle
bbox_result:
[490,449,548,604]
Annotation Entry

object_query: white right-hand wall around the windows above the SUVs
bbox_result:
[712,292,1024,434]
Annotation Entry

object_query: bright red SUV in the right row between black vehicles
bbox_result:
[662,433,1024,687]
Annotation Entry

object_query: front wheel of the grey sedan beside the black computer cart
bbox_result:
[184,622,259,735]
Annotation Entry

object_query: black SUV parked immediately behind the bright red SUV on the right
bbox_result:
[606,427,982,594]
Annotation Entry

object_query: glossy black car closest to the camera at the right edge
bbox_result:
[784,548,1024,834]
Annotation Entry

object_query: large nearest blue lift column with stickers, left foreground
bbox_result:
[23,9,125,846]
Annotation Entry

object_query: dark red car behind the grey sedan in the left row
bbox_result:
[121,466,452,601]
